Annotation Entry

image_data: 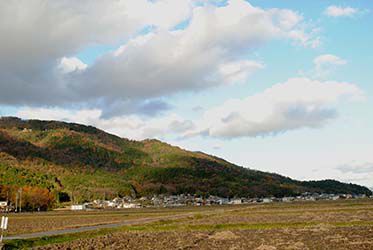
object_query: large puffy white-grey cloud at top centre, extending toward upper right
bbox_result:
[71,0,311,115]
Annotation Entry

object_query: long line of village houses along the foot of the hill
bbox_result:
[71,193,373,210]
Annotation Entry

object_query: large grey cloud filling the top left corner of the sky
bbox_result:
[0,0,192,105]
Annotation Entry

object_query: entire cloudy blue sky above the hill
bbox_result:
[0,0,373,187]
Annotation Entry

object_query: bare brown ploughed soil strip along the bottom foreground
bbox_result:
[37,227,373,250]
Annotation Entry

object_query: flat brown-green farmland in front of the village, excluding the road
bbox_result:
[2,200,373,250]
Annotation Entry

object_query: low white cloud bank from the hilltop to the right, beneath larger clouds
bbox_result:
[17,78,364,139]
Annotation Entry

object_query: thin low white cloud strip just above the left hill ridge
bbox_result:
[16,107,194,140]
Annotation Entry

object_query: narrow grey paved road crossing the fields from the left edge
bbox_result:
[4,212,194,240]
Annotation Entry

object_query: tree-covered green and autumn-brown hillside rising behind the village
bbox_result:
[0,117,371,207]
